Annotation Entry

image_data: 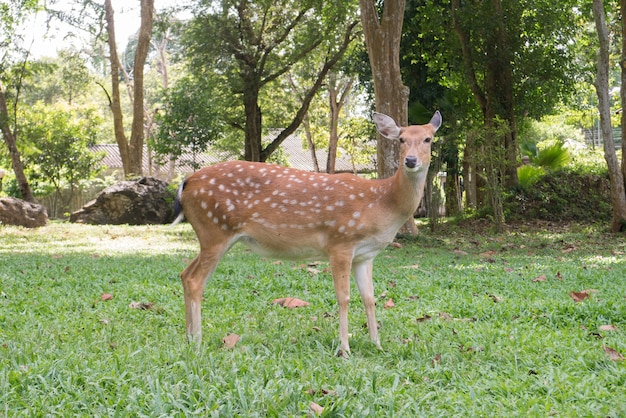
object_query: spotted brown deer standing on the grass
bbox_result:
[172,111,442,357]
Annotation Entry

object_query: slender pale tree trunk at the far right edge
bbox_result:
[592,0,626,232]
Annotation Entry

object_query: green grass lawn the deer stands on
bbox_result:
[0,223,626,417]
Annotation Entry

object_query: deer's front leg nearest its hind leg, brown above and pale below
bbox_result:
[330,251,352,357]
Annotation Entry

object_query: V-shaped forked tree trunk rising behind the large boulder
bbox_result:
[104,0,154,177]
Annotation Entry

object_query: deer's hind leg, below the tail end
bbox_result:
[180,243,225,345]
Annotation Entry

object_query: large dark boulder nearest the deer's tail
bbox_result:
[70,177,174,225]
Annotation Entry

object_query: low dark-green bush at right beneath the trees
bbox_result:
[505,170,612,222]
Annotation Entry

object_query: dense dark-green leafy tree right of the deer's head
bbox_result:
[402,0,587,220]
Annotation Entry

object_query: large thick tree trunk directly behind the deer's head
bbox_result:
[359,0,417,235]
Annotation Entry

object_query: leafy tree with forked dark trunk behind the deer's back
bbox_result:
[187,0,358,161]
